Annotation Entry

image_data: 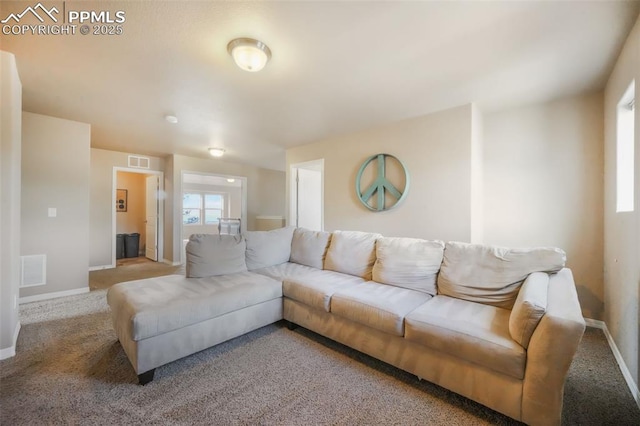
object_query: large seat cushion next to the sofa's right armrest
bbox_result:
[405,296,527,380]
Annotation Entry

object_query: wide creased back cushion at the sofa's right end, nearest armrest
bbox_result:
[438,242,566,309]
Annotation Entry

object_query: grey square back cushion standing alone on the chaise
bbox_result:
[186,234,247,278]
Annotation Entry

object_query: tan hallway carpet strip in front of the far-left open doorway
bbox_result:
[89,256,184,291]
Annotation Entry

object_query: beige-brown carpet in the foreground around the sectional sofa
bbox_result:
[0,290,640,425]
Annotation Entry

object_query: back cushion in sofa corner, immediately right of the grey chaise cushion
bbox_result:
[243,226,295,271]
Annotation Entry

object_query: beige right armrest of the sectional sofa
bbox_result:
[522,268,585,425]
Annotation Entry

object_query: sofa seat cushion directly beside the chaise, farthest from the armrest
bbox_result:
[282,269,365,312]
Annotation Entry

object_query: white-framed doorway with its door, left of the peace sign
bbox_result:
[289,159,324,231]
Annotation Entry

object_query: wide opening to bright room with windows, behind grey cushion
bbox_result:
[179,171,247,263]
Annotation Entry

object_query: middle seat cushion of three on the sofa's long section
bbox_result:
[331,281,431,336]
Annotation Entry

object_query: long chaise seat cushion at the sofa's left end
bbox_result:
[107,272,282,341]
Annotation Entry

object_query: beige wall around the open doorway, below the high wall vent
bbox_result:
[89,148,168,268]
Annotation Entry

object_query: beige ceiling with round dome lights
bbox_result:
[0,1,640,169]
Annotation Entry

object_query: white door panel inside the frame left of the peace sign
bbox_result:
[296,168,322,231]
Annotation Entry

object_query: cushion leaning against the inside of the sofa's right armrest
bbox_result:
[509,272,549,349]
